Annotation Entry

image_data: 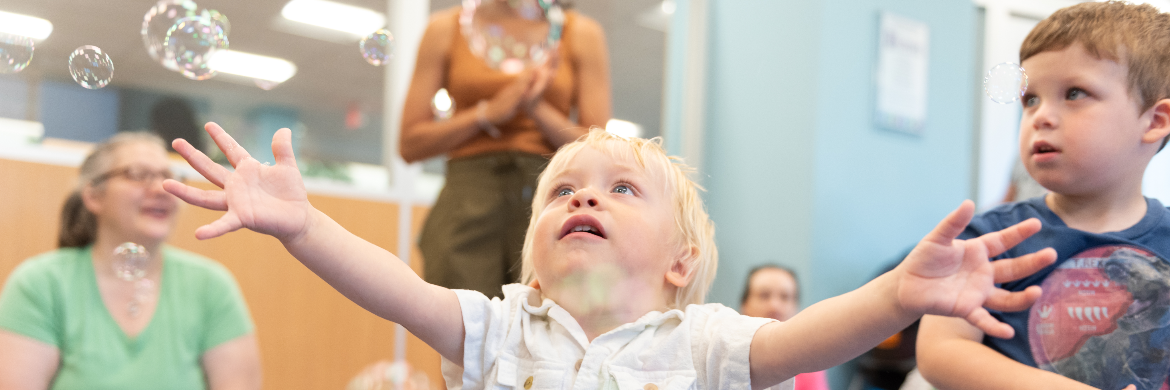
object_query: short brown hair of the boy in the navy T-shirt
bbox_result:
[1020,1,1170,112]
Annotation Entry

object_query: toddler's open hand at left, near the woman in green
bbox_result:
[163,123,312,241]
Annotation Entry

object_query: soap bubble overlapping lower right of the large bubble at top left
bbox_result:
[165,14,228,80]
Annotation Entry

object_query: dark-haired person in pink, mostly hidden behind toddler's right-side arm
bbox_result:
[739,265,828,390]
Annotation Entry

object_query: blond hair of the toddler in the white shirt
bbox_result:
[521,128,718,309]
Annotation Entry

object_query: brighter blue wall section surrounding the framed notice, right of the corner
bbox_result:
[806,0,979,309]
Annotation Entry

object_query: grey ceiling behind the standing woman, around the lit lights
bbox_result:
[0,0,665,134]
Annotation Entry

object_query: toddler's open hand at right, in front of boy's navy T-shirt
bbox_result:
[897,200,1057,338]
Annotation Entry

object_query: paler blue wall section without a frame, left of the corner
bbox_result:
[702,1,821,308]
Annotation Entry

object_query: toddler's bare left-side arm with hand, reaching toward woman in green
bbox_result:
[163,123,463,362]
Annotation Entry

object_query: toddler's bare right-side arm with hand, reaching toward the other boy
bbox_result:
[750,200,1057,389]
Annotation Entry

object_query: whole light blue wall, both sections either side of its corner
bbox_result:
[692,0,979,389]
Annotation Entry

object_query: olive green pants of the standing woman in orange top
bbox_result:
[419,152,549,297]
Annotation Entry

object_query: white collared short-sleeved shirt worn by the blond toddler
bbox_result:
[442,285,792,390]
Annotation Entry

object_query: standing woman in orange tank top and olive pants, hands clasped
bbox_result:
[400,0,611,296]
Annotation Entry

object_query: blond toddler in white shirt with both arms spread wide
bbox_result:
[164,123,1054,390]
